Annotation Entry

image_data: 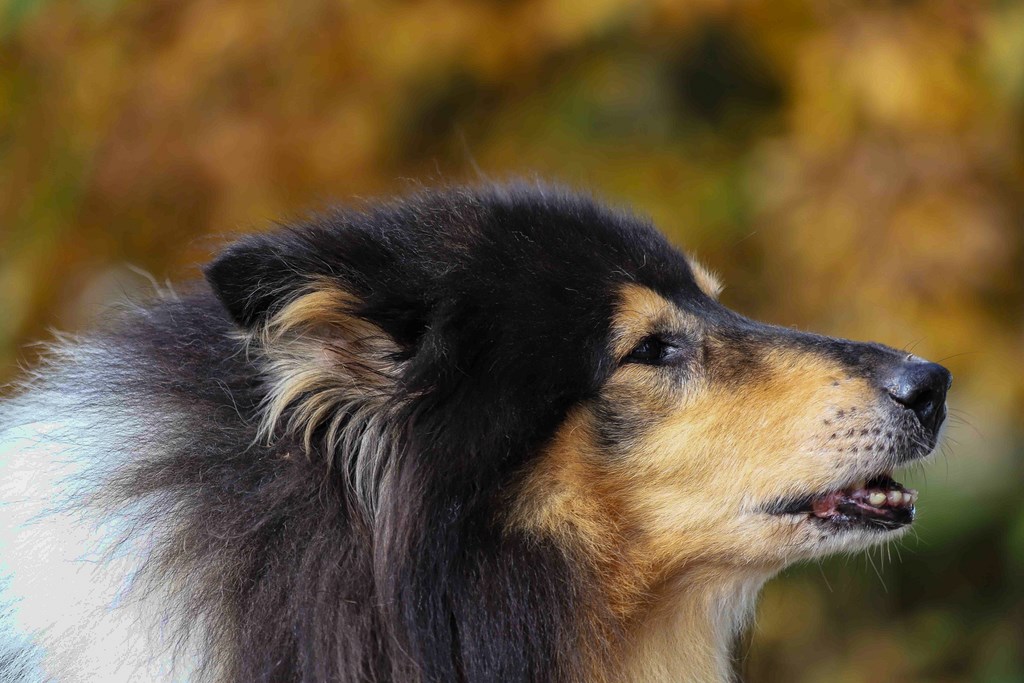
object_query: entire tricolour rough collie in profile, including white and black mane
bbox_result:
[0,185,950,683]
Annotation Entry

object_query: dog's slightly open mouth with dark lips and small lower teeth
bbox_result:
[772,473,918,530]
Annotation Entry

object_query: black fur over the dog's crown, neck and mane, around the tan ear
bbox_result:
[28,185,697,682]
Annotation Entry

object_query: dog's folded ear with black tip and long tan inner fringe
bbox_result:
[206,230,403,491]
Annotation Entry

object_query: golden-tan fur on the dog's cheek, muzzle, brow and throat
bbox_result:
[511,286,905,681]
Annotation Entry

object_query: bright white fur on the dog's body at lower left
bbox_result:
[0,368,198,683]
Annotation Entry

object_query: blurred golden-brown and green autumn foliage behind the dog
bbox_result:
[0,0,1024,683]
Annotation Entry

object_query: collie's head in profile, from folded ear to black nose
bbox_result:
[207,185,950,679]
